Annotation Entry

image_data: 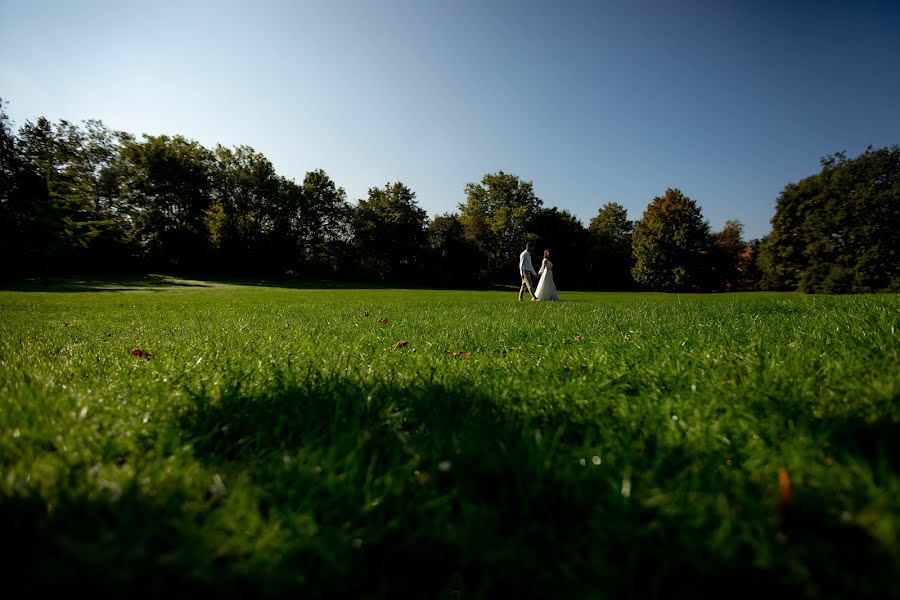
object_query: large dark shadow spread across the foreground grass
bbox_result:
[0,374,896,598]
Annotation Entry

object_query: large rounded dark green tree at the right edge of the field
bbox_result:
[759,146,900,293]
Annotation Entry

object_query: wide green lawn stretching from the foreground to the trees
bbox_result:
[0,278,900,598]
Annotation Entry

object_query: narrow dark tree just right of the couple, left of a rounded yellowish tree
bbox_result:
[588,202,634,289]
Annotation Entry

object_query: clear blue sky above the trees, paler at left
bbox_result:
[0,0,900,239]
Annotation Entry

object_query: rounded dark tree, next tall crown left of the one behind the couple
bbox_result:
[352,181,428,280]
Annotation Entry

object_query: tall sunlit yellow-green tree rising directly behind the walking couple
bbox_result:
[459,171,543,278]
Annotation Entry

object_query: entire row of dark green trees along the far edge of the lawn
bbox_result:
[0,102,900,291]
